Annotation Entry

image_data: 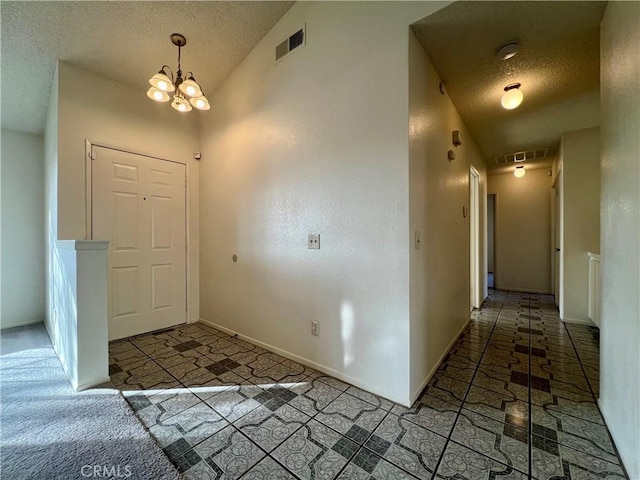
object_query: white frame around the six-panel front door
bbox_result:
[84,139,193,323]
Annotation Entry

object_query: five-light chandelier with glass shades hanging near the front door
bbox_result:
[147,33,211,112]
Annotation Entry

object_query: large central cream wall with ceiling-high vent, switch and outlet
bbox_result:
[200,2,452,403]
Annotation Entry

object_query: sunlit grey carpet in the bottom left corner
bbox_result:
[0,324,180,480]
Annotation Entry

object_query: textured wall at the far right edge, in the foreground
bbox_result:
[600,2,640,478]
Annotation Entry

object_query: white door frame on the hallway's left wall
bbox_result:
[469,166,482,311]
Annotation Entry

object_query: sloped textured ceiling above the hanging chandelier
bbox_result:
[0,1,293,133]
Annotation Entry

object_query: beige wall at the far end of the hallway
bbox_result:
[488,168,552,293]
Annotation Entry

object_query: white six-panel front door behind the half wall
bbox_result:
[92,146,187,340]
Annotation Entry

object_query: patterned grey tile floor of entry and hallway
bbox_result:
[110,290,626,480]
